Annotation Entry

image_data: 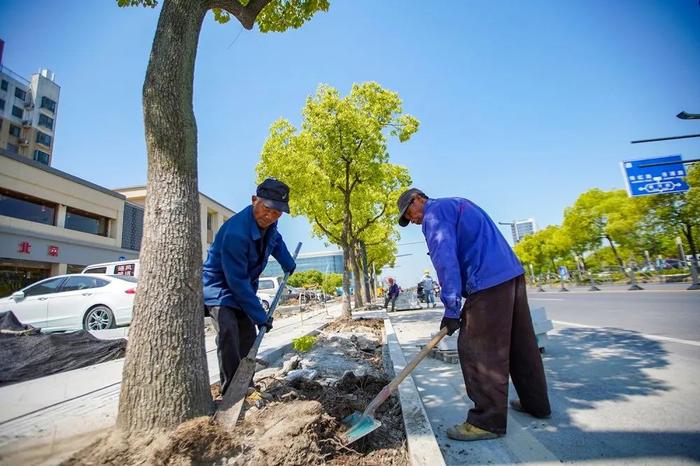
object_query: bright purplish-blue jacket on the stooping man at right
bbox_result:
[422,197,524,319]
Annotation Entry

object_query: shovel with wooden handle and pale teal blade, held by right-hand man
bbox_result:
[342,327,447,445]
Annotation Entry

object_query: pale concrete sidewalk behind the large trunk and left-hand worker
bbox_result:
[0,303,341,465]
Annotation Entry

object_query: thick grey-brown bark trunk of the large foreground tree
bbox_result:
[117,0,212,435]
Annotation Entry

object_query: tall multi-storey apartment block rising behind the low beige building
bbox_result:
[0,41,61,165]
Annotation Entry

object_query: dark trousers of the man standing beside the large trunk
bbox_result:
[208,306,257,395]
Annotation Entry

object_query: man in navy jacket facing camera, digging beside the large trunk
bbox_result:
[202,178,296,394]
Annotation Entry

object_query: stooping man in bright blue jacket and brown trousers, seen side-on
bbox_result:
[398,188,550,440]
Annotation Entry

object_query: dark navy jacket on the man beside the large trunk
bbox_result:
[202,206,296,324]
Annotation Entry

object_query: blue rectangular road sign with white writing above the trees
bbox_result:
[622,154,689,196]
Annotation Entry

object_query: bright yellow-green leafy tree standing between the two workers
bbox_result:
[256,82,418,317]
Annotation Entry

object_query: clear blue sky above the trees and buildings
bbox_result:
[0,0,700,284]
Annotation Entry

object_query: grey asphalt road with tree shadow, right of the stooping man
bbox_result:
[524,285,700,464]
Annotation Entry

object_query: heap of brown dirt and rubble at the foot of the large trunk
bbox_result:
[65,320,408,466]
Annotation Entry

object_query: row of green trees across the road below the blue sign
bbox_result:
[515,166,700,280]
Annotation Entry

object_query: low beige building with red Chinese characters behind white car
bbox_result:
[0,149,138,295]
